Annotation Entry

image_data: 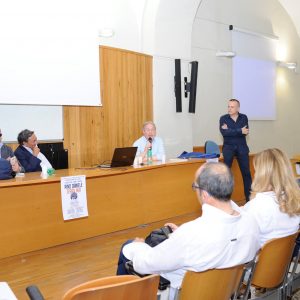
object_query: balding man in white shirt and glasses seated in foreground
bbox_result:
[117,162,259,298]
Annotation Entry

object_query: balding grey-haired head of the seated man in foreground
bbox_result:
[196,162,234,202]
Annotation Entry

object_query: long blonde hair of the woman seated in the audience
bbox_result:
[251,148,300,216]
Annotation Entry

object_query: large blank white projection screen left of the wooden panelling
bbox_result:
[0,0,101,106]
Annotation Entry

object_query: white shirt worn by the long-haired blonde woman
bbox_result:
[244,192,300,246]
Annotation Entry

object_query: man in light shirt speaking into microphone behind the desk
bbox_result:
[133,121,165,162]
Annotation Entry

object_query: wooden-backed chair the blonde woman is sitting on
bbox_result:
[245,232,298,299]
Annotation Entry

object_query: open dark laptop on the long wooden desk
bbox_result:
[99,147,137,168]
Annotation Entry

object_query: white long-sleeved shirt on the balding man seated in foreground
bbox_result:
[123,202,259,288]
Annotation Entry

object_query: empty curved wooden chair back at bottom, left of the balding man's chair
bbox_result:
[63,275,159,300]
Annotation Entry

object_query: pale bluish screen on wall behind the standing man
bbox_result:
[232,31,277,120]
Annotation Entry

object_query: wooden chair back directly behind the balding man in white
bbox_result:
[179,264,244,300]
